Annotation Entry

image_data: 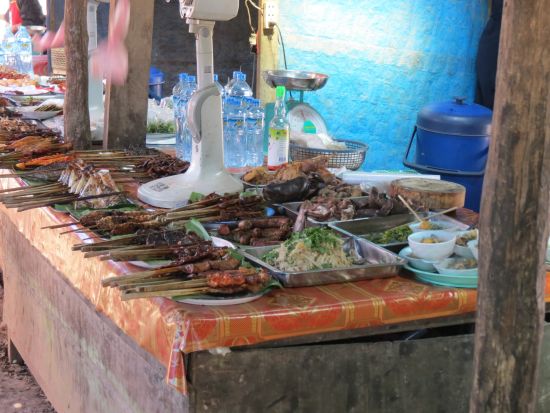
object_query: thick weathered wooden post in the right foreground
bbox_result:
[470,0,550,413]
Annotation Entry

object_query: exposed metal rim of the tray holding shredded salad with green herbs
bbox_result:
[240,237,406,287]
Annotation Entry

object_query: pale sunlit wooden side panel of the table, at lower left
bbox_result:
[0,214,187,413]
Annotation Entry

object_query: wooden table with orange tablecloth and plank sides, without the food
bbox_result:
[0,172,550,412]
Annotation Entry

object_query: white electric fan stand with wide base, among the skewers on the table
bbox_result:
[138,0,243,208]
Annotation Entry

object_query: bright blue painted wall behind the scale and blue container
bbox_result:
[279,0,488,170]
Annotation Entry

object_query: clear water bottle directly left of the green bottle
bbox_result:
[245,99,265,167]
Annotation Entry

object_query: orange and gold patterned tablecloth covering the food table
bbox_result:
[0,172,550,393]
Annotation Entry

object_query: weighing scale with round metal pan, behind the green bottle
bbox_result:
[263,70,328,142]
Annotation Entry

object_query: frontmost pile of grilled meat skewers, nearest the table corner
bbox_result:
[102,237,271,300]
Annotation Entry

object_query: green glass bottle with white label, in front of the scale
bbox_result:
[267,86,290,171]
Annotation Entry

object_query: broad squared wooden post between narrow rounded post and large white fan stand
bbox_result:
[103,0,155,148]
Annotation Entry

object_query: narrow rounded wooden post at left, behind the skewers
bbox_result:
[64,0,92,149]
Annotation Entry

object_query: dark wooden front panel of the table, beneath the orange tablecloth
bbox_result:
[188,326,550,413]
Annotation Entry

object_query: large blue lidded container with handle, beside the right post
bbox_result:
[403,98,492,211]
